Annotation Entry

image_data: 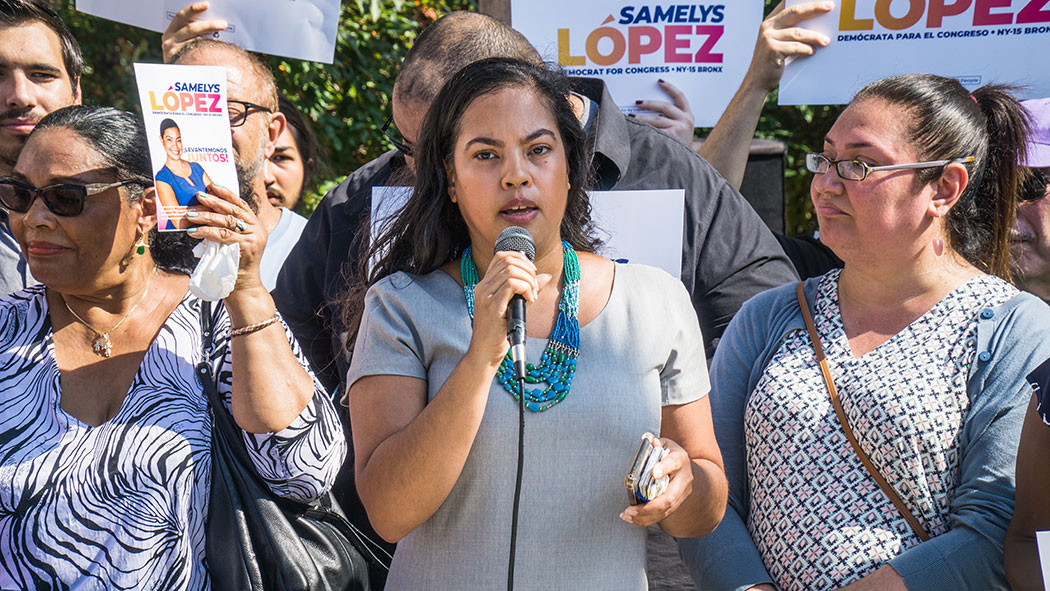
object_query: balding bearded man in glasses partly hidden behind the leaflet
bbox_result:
[171,38,307,291]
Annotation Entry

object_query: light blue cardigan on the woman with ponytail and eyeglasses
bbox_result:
[678,277,1050,591]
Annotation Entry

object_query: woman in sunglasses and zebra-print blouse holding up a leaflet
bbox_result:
[0,106,345,589]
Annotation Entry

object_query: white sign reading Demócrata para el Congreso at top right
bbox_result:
[779,0,1050,105]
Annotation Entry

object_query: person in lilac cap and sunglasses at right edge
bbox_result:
[1010,99,1050,303]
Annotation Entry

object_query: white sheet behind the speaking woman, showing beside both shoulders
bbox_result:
[371,187,686,278]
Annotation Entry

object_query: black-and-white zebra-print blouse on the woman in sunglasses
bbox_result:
[0,286,347,590]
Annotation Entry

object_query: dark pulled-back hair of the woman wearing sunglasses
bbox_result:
[29,105,196,274]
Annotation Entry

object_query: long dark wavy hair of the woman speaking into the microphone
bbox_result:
[341,58,600,349]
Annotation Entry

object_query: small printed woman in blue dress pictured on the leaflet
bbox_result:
[155,118,211,230]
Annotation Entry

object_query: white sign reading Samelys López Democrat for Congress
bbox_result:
[510,0,762,127]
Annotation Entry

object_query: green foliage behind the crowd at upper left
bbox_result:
[56,0,476,212]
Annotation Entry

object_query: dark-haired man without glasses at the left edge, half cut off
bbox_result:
[0,0,84,295]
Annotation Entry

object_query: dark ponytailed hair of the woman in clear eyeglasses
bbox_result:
[853,73,1029,280]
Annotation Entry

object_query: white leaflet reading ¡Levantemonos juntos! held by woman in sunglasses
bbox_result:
[134,64,237,232]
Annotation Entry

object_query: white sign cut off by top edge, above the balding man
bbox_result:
[77,0,339,64]
